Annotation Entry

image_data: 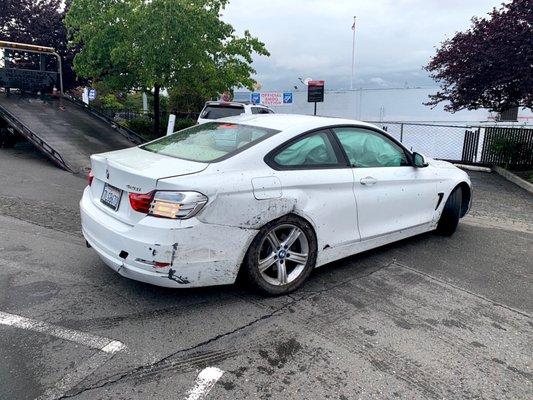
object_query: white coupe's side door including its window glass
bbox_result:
[333,126,439,240]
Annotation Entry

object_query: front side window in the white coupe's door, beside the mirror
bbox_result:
[334,127,409,168]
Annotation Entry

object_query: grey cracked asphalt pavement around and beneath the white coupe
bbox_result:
[0,144,533,399]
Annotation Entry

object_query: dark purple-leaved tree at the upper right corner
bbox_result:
[426,0,533,112]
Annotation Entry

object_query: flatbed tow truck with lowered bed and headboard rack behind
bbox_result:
[0,40,144,173]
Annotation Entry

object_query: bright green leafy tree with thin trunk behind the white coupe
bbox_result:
[65,0,269,135]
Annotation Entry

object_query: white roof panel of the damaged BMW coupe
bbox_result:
[217,114,375,131]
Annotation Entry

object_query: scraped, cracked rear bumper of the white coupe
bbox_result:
[80,189,257,288]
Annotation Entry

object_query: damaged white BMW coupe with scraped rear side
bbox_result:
[80,115,471,295]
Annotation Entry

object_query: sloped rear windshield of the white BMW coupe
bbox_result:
[141,122,279,162]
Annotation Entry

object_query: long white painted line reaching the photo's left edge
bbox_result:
[0,311,126,354]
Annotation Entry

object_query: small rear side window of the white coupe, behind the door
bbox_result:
[274,131,338,167]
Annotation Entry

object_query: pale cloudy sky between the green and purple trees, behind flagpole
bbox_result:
[223,0,502,90]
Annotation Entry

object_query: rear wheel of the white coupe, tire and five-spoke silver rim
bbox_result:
[243,215,317,296]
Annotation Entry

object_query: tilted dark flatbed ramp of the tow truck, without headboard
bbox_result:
[0,93,142,173]
